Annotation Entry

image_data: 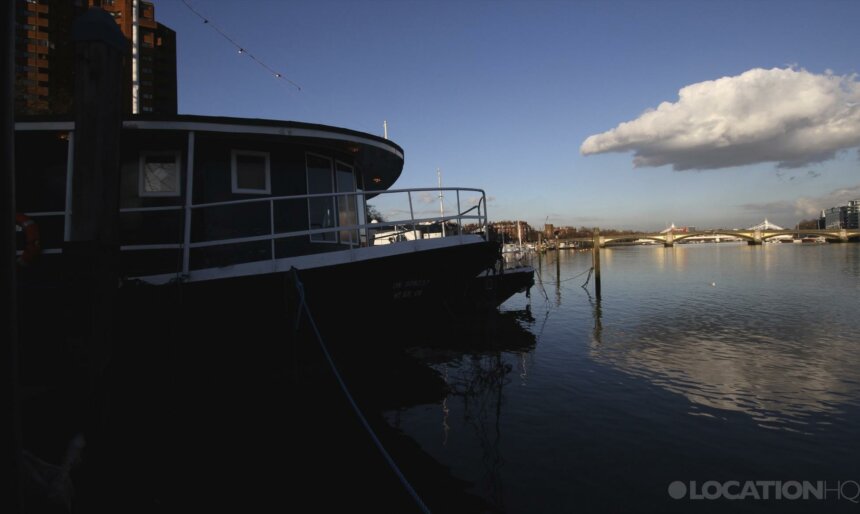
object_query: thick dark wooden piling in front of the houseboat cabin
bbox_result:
[63,8,128,467]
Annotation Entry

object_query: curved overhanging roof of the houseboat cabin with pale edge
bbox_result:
[15,114,404,191]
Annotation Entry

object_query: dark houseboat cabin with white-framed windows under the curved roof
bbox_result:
[15,115,486,283]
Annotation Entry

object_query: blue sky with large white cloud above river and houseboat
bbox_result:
[154,0,860,231]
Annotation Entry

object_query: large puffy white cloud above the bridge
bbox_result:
[580,68,860,170]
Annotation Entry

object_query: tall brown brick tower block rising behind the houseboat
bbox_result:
[13,0,178,115]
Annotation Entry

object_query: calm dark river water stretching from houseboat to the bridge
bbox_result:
[386,243,860,513]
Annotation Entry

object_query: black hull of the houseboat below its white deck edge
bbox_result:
[123,238,508,328]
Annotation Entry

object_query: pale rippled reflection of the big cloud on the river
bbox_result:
[593,328,860,428]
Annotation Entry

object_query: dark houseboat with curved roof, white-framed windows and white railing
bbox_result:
[15,115,531,316]
